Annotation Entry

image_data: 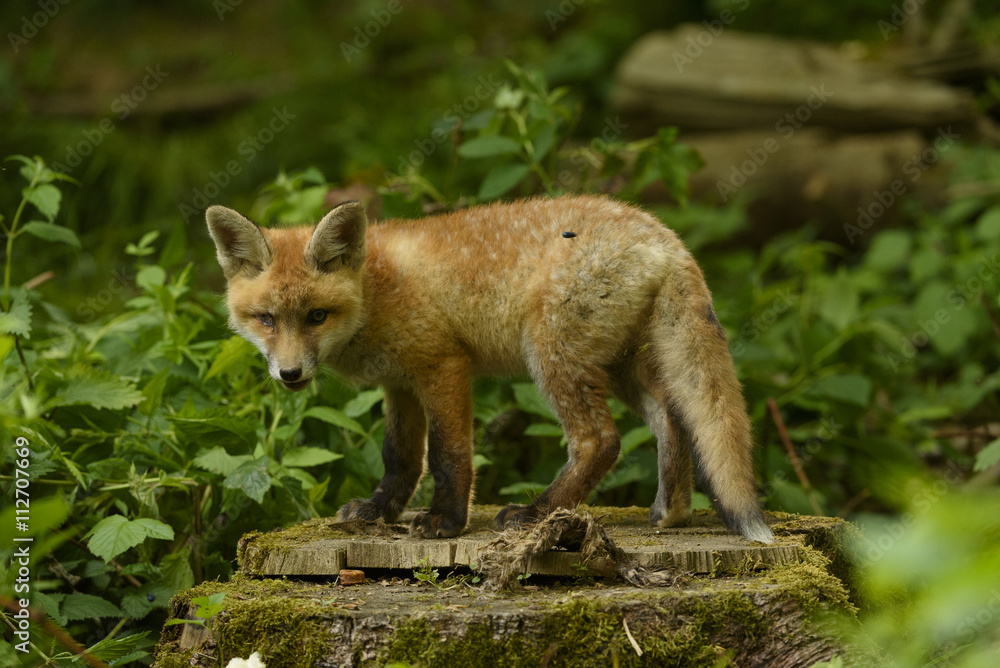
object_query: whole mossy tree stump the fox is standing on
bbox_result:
[154,507,855,668]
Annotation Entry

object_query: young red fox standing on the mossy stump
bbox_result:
[206,195,774,543]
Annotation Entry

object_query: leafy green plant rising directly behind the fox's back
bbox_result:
[385,61,701,209]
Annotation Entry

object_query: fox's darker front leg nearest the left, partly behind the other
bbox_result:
[337,387,427,522]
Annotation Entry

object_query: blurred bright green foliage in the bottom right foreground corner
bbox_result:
[851,486,1000,668]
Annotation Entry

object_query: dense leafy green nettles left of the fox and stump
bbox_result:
[0,157,382,665]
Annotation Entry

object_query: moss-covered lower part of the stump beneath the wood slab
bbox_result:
[154,509,856,668]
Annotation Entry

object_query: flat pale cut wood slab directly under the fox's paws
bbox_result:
[239,506,839,576]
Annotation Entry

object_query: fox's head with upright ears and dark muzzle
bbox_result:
[205,202,368,391]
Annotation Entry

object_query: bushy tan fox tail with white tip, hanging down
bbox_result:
[652,260,774,543]
